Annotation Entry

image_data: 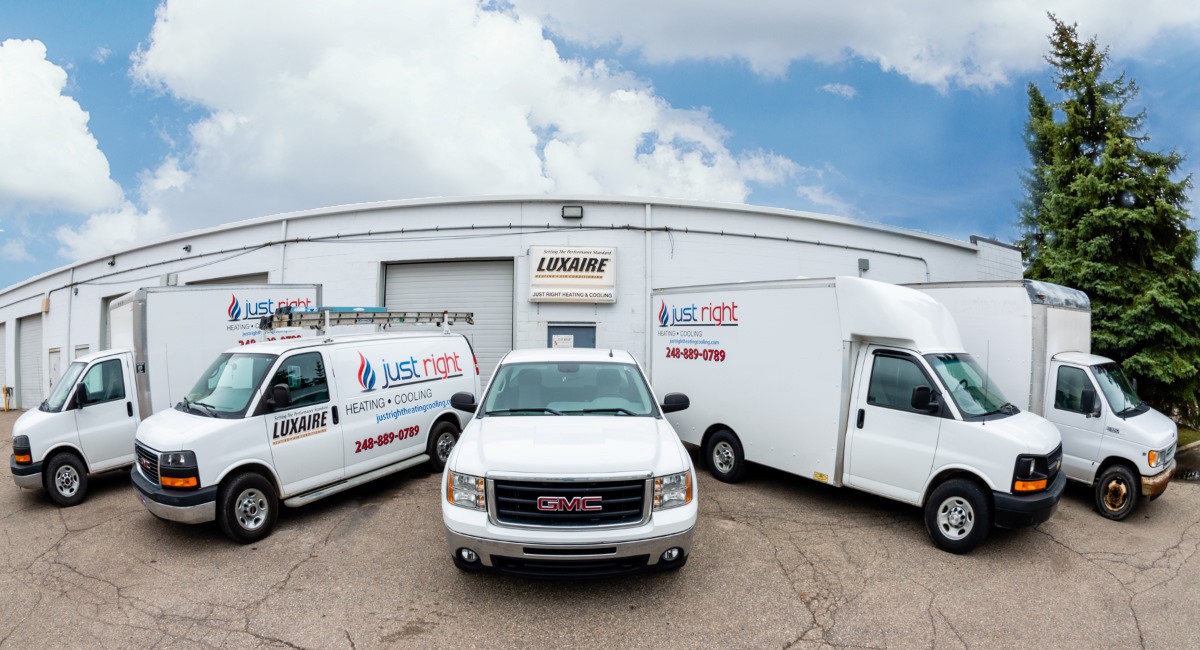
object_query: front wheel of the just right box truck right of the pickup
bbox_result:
[925,479,991,554]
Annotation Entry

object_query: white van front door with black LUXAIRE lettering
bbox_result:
[259,350,344,496]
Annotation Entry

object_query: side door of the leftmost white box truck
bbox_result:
[74,357,138,471]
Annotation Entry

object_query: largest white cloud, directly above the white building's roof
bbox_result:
[51,0,797,247]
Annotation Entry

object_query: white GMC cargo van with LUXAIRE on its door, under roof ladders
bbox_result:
[132,314,479,543]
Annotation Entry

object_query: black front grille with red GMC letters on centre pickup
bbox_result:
[491,480,649,526]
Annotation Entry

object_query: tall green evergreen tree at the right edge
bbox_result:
[1020,14,1200,422]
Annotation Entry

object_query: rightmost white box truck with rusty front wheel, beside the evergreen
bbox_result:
[911,279,1178,519]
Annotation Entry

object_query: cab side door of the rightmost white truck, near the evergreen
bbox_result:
[1042,361,1104,482]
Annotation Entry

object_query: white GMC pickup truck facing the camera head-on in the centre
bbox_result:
[442,349,698,577]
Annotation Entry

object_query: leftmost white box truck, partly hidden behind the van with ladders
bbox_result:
[10,284,320,506]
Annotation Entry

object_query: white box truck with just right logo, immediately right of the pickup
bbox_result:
[650,277,1066,553]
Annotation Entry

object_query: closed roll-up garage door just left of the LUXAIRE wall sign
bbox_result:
[384,260,512,385]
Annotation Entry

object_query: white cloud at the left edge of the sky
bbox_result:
[0,40,121,212]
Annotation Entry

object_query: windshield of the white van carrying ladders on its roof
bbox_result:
[175,353,276,417]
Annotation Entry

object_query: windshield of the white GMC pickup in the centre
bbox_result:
[484,362,655,416]
